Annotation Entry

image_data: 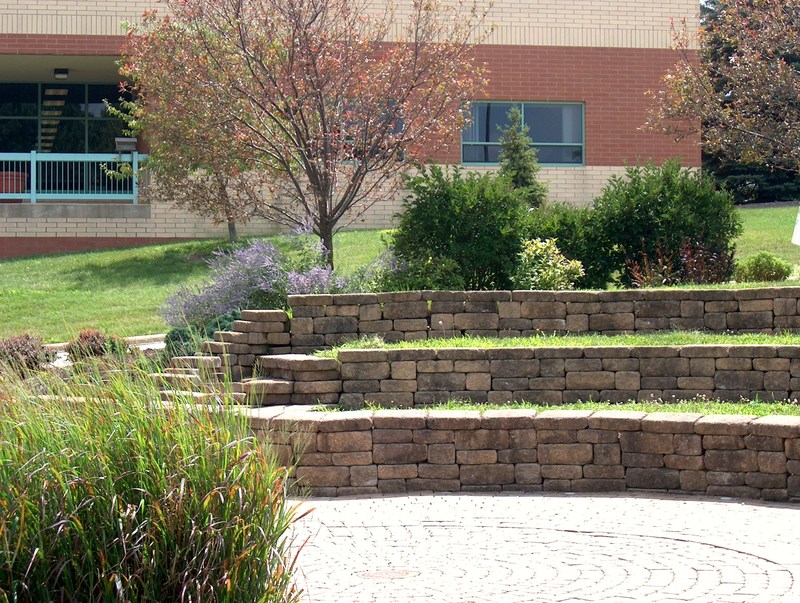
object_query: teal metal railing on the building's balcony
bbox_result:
[0,151,146,203]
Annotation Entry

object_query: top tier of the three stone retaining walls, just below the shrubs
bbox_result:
[289,287,800,352]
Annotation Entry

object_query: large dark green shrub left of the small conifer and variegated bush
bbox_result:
[392,166,527,289]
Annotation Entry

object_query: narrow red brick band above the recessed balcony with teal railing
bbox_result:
[0,34,125,56]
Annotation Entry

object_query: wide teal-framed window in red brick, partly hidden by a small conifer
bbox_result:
[461,101,584,165]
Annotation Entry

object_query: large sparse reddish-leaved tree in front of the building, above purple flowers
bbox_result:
[123,0,486,265]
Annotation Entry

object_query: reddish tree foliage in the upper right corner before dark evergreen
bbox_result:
[650,0,800,170]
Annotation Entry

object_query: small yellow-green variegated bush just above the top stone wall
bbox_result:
[512,239,583,290]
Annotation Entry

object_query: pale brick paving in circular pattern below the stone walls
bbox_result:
[296,494,800,603]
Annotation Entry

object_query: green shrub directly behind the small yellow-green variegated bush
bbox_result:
[527,203,616,289]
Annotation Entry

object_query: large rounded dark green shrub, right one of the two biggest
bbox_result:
[591,161,741,285]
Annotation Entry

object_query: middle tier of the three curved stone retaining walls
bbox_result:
[339,345,800,408]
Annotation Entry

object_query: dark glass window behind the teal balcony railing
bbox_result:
[0,82,130,153]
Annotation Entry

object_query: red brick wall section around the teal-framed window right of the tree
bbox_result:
[437,46,700,167]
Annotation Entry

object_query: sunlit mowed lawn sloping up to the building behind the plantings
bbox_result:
[0,206,800,342]
